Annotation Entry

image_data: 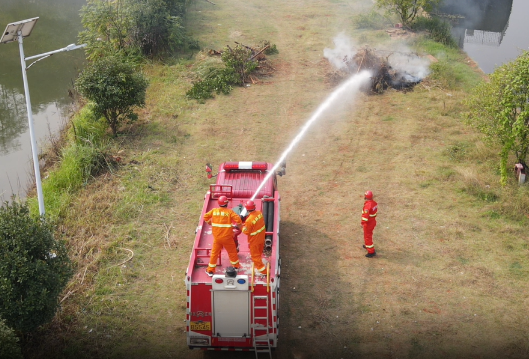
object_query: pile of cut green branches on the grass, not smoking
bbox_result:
[186,41,278,101]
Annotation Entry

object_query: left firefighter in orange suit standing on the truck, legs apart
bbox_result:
[204,196,242,277]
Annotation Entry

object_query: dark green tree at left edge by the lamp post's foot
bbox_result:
[0,200,72,332]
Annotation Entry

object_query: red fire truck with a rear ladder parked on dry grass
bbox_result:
[185,162,285,356]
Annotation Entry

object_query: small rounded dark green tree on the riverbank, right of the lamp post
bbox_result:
[75,56,148,137]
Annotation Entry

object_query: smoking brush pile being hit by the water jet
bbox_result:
[328,47,424,94]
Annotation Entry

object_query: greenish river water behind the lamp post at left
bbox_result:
[0,0,86,201]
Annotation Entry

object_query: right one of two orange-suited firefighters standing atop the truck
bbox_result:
[242,201,266,275]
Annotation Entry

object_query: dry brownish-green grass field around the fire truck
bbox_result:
[26,0,529,359]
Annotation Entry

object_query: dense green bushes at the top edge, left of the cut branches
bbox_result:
[79,0,196,60]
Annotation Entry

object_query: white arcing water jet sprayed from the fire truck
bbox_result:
[251,71,371,200]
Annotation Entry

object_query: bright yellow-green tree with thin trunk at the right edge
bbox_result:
[466,51,529,185]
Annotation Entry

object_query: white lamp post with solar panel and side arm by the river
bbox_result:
[0,17,86,216]
